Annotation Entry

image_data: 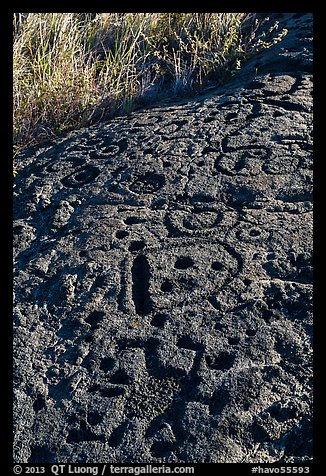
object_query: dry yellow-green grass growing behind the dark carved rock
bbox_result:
[13,13,266,149]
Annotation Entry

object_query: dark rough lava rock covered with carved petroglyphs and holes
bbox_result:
[13,14,312,463]
